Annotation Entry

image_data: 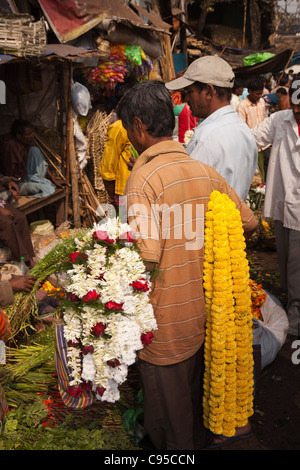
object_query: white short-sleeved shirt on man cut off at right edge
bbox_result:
[252,109,300,230]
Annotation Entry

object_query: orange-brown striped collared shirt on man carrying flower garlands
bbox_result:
[125,140,257,365]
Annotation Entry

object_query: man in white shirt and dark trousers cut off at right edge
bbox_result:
[252,77,300,336]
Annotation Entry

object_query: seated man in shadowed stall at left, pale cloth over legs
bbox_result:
[1,119,61,197]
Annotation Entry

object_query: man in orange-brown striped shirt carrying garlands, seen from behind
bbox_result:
[118,81,257,450]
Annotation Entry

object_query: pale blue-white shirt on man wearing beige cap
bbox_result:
[186,105,258,201]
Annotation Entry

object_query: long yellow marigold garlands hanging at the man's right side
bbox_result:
[203,191,254,437]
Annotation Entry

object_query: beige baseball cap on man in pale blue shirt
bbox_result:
[166,55,234,90]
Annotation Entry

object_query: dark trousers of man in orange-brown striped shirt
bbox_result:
[137,346,204,450]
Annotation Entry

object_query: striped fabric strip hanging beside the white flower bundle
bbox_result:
[53,312,96,409]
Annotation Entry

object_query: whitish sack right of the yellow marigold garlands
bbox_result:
[253,291,289,369]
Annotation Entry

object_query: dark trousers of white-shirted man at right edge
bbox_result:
[275,220,300,336]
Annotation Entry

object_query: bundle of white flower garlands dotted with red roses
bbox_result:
[45,218,157,402]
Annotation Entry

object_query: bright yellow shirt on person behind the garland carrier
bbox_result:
[100,119,131,196]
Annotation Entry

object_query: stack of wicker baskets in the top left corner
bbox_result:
[0,15,47,57]
